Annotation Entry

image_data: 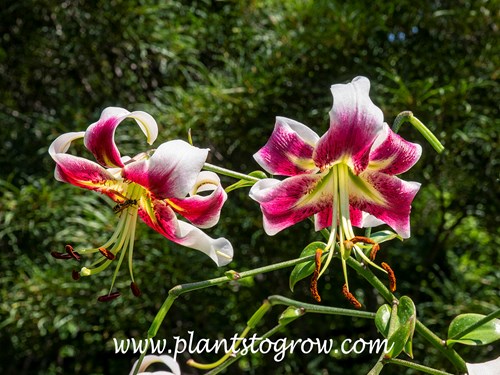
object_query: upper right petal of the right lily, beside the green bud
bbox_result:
[370,124,422,175]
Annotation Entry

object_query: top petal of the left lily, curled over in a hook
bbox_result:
[84,107,158,168]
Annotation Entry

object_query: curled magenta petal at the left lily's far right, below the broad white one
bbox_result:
[167,171,227,228]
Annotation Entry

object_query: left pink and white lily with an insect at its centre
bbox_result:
[49,107,233,300]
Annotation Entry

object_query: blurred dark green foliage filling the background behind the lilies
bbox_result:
[0,0,500,374]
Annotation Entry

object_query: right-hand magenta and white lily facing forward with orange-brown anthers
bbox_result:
[250,77,422,298]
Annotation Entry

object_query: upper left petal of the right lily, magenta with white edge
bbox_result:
[254,117,319,176]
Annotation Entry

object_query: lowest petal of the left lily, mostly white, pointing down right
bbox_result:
[139,201,233,266]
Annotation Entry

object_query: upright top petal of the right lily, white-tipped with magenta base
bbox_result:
[313,77,384,174]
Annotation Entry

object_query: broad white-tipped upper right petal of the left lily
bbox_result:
[122,140,208,199]
